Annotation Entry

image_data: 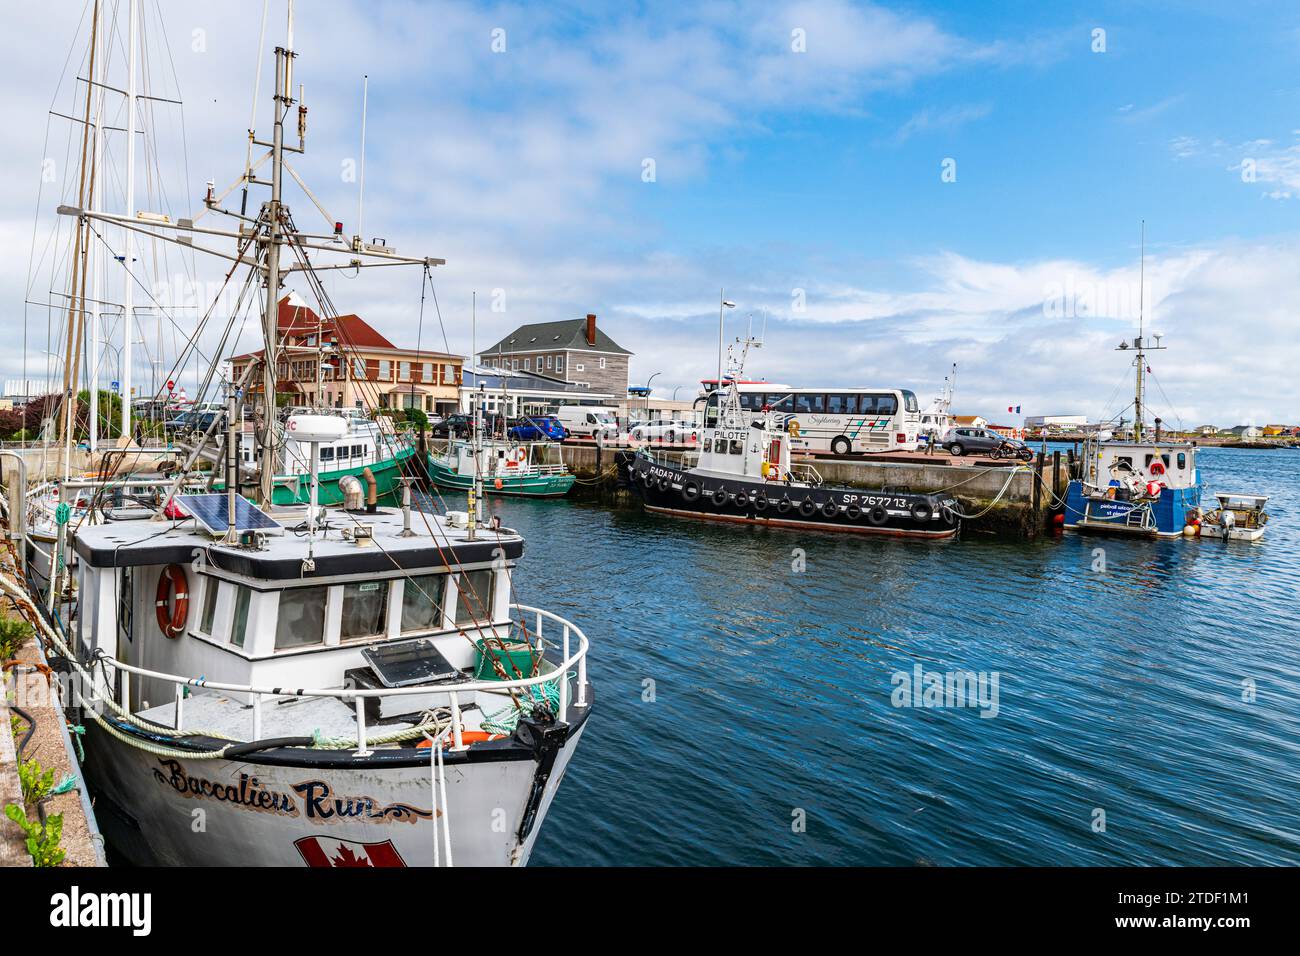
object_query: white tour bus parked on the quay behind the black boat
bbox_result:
[705,382,920,455]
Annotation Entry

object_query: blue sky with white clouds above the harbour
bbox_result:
[0,0,1300,424]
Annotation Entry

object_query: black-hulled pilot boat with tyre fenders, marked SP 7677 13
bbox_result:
[619,330,961,538]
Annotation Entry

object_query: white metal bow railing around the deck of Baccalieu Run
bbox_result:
[100,604,589,754]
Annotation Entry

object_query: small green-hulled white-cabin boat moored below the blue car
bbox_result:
[429,438,576,498]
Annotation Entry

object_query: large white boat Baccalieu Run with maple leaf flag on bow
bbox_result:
[0,0,593,866]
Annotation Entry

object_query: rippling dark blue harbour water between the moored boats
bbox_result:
[488,449,1300,865]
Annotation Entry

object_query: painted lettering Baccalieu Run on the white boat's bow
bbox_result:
[153,758,433,823]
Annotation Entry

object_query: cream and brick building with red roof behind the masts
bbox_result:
[230,293,464,414]
